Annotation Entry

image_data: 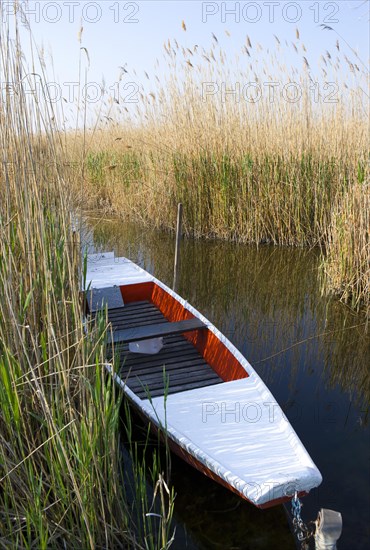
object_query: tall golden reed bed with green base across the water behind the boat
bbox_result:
[74,31,370,313]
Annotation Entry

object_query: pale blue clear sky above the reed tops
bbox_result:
[2,0,370,125]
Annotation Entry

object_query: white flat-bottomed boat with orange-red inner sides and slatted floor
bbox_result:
[86,253,322,508]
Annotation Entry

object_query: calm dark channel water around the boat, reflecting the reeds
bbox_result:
[87,219,370,550]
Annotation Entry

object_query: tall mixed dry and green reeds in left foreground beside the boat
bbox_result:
[0,6,172,549]
